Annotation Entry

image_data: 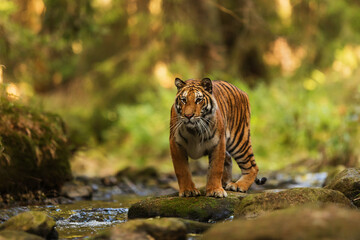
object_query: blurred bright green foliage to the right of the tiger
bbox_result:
[248,75,360,169]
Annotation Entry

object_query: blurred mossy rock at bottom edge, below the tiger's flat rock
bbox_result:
[92,218,187,240]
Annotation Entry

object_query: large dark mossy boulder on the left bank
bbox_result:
[0,99,71,193]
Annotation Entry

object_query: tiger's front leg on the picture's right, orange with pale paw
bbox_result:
[206,136,227,198]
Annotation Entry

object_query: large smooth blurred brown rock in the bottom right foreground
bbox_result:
[203,205,360,240]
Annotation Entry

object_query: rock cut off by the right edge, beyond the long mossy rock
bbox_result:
[325,168,360,207]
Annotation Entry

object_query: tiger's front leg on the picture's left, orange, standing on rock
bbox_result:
[170,139,200,197]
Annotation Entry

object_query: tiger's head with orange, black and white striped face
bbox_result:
[175,78,216,128]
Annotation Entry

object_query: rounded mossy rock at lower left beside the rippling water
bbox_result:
[0,211,57,239]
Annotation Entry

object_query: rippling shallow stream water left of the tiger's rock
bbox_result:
[0,196,144,239]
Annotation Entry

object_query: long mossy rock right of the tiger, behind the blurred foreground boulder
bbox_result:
[234,188,353,218]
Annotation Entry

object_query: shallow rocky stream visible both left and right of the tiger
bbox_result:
[0,173,327,239]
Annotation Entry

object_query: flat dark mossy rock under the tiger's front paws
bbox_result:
[128,192,245,222]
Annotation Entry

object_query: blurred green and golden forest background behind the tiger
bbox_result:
[0,0,360,176]
